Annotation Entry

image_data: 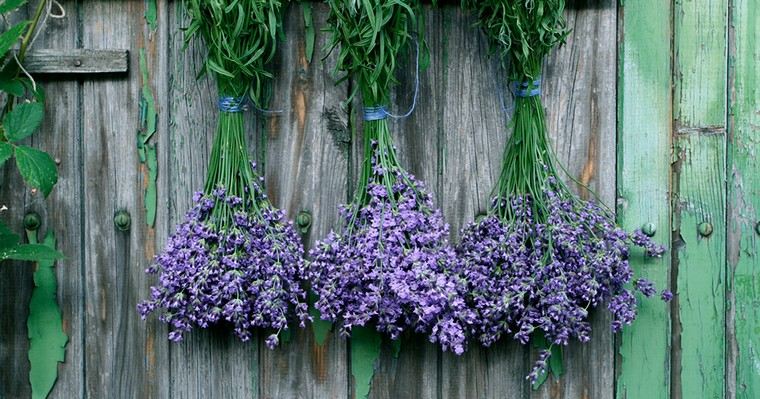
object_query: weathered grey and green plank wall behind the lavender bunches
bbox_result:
[0,0,760,399]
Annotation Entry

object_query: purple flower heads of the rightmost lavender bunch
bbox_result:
[457,181,665,380]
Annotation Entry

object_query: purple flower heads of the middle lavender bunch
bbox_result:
[310,155,475,354]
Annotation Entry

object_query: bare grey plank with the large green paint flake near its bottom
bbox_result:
[27,1,85,398]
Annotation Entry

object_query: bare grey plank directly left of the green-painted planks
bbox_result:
[536,0,617,399]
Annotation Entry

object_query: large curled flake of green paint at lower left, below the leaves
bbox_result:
[26,231,69,399]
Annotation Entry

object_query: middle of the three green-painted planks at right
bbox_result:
[671,0,728,398]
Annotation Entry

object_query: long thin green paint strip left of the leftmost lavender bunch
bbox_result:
[137,48,158,227]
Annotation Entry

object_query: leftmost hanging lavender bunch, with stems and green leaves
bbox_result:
[138,0,309,348]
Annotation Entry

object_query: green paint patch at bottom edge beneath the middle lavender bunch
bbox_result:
[351,327,382,399]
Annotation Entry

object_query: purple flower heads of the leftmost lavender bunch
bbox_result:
[138,187,310,347]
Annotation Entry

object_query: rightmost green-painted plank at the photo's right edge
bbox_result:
[726,0,760,399]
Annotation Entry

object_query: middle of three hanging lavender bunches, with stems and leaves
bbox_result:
[310,0,473,353]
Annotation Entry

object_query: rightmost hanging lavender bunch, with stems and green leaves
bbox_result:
[464,0,670,383]
